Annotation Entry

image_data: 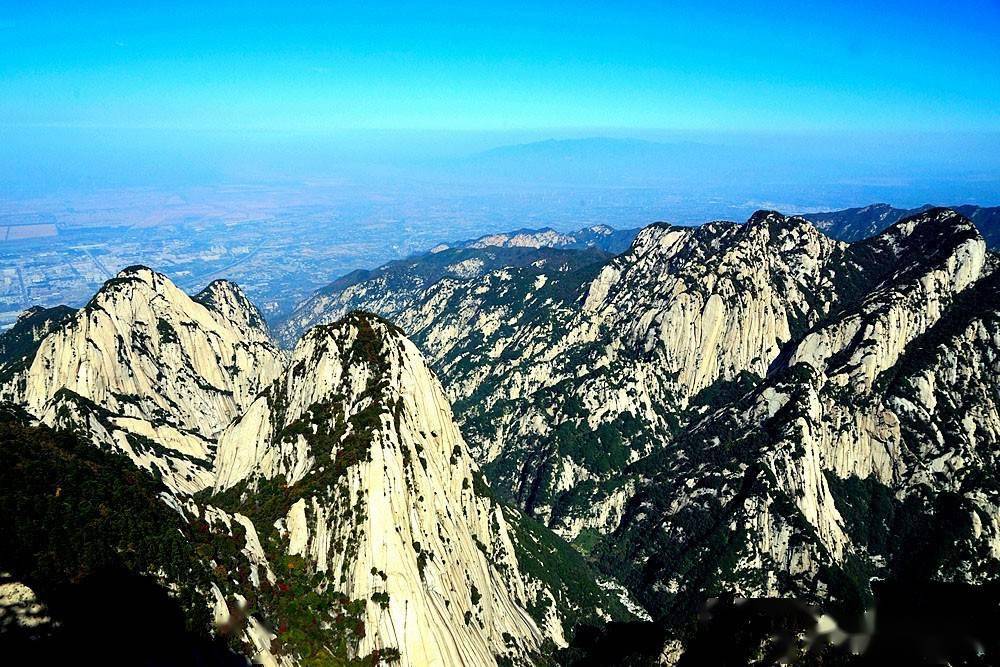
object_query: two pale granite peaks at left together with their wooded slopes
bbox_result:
[0,267,633,665]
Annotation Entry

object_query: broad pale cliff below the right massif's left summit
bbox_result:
[583,212,844,408]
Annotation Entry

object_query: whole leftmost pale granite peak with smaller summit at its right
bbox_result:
[5,267,283,492]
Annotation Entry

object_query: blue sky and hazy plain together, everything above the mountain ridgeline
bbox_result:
[0,0,1000,322]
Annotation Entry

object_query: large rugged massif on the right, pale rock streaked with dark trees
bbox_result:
[264,208,1000,664]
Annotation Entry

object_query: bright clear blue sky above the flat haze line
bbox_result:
[0,0,1000,133]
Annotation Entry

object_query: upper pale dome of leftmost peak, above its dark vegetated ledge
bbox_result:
[27,266,280,435]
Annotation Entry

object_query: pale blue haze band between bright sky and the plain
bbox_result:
[0,128,1000,208]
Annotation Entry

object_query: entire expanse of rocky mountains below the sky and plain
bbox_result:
[0,205,1000,665]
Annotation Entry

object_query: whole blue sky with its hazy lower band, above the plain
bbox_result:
[0,0,1000,205]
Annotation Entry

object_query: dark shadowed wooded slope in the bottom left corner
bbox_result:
[0,407,241,664]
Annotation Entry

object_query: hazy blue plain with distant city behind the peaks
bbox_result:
[0,177,754,327]
